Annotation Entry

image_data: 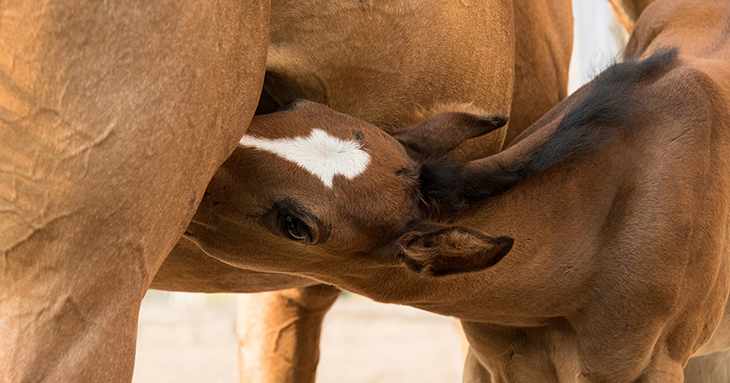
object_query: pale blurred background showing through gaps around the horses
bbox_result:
[133,0,627,383]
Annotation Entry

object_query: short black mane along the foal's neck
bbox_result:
[420,48,678,215]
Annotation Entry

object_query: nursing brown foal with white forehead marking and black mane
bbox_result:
[179,0,730,383]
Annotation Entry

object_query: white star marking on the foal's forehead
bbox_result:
[240,129,370,188]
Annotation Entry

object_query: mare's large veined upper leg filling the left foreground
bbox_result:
[0,0,268,382]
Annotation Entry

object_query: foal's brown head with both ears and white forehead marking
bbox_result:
[186,101,512,275]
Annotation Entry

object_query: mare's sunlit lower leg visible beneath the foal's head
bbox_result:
[237,285,341,383]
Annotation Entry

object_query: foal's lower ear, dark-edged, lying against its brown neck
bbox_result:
[398,226,514,276]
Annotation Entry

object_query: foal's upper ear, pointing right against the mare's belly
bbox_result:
[394,112,507,160]
